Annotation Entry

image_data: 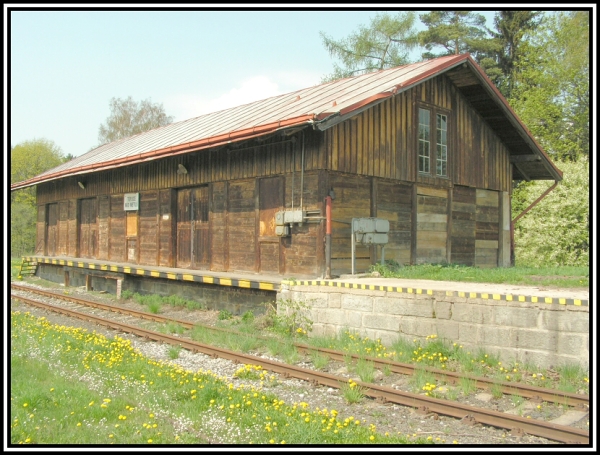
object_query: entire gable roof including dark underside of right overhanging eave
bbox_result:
[11,54,562,191]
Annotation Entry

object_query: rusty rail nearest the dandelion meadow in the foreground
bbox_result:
[11,294,589,444]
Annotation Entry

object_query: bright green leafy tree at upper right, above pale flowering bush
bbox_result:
[509,11,590,160]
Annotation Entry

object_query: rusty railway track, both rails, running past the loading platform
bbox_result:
[11,285,589,444]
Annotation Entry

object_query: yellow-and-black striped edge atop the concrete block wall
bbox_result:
[281,280,589,306]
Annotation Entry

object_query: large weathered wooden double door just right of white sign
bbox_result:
[177,186,210,268]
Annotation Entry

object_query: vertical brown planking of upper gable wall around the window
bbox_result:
[325,75,511,191]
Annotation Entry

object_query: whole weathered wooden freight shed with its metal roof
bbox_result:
[11,54,562,278]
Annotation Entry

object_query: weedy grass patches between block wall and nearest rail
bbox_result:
[14,280,589,404]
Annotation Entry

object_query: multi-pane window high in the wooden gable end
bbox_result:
[417,108,448,177]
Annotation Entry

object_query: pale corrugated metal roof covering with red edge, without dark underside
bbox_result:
[11,54,562,190]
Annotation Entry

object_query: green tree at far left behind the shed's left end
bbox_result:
[10,139,65,257]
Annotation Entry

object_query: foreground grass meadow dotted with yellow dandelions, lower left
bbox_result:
[9,312,428,447]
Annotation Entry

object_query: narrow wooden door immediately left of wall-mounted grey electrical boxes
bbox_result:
[258,177,283,274]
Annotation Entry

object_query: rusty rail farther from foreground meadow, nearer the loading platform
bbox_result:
[11,284,589,410]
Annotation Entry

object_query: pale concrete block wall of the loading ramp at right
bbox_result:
[277,283,590,368]
